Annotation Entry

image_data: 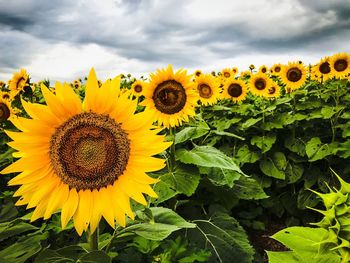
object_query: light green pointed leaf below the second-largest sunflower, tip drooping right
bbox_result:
[175,146,243,174]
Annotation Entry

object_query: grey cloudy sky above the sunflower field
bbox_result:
[0,0,350,81]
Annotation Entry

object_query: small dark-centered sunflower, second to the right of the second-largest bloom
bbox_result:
[222,78,248,102]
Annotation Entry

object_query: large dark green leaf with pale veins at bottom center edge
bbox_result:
[188,213,254,263]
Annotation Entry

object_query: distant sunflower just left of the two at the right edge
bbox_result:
[279,61,306,92]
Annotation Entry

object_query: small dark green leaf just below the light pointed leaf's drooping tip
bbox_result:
[232,176,268,200]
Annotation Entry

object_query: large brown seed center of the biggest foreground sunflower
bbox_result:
[50,112,130,190]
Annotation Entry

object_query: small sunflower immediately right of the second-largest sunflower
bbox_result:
[195,74,220,106]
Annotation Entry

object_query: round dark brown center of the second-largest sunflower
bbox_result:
[152,80,187,114]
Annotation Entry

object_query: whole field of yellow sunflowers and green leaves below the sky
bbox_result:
[0,53,350,263]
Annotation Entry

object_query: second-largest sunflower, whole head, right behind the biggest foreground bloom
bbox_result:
[140,65,198,128]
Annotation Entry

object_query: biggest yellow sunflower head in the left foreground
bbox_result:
[2,69,169,235]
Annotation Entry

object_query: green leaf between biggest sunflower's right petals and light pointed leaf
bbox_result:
[160,166,200,196]
